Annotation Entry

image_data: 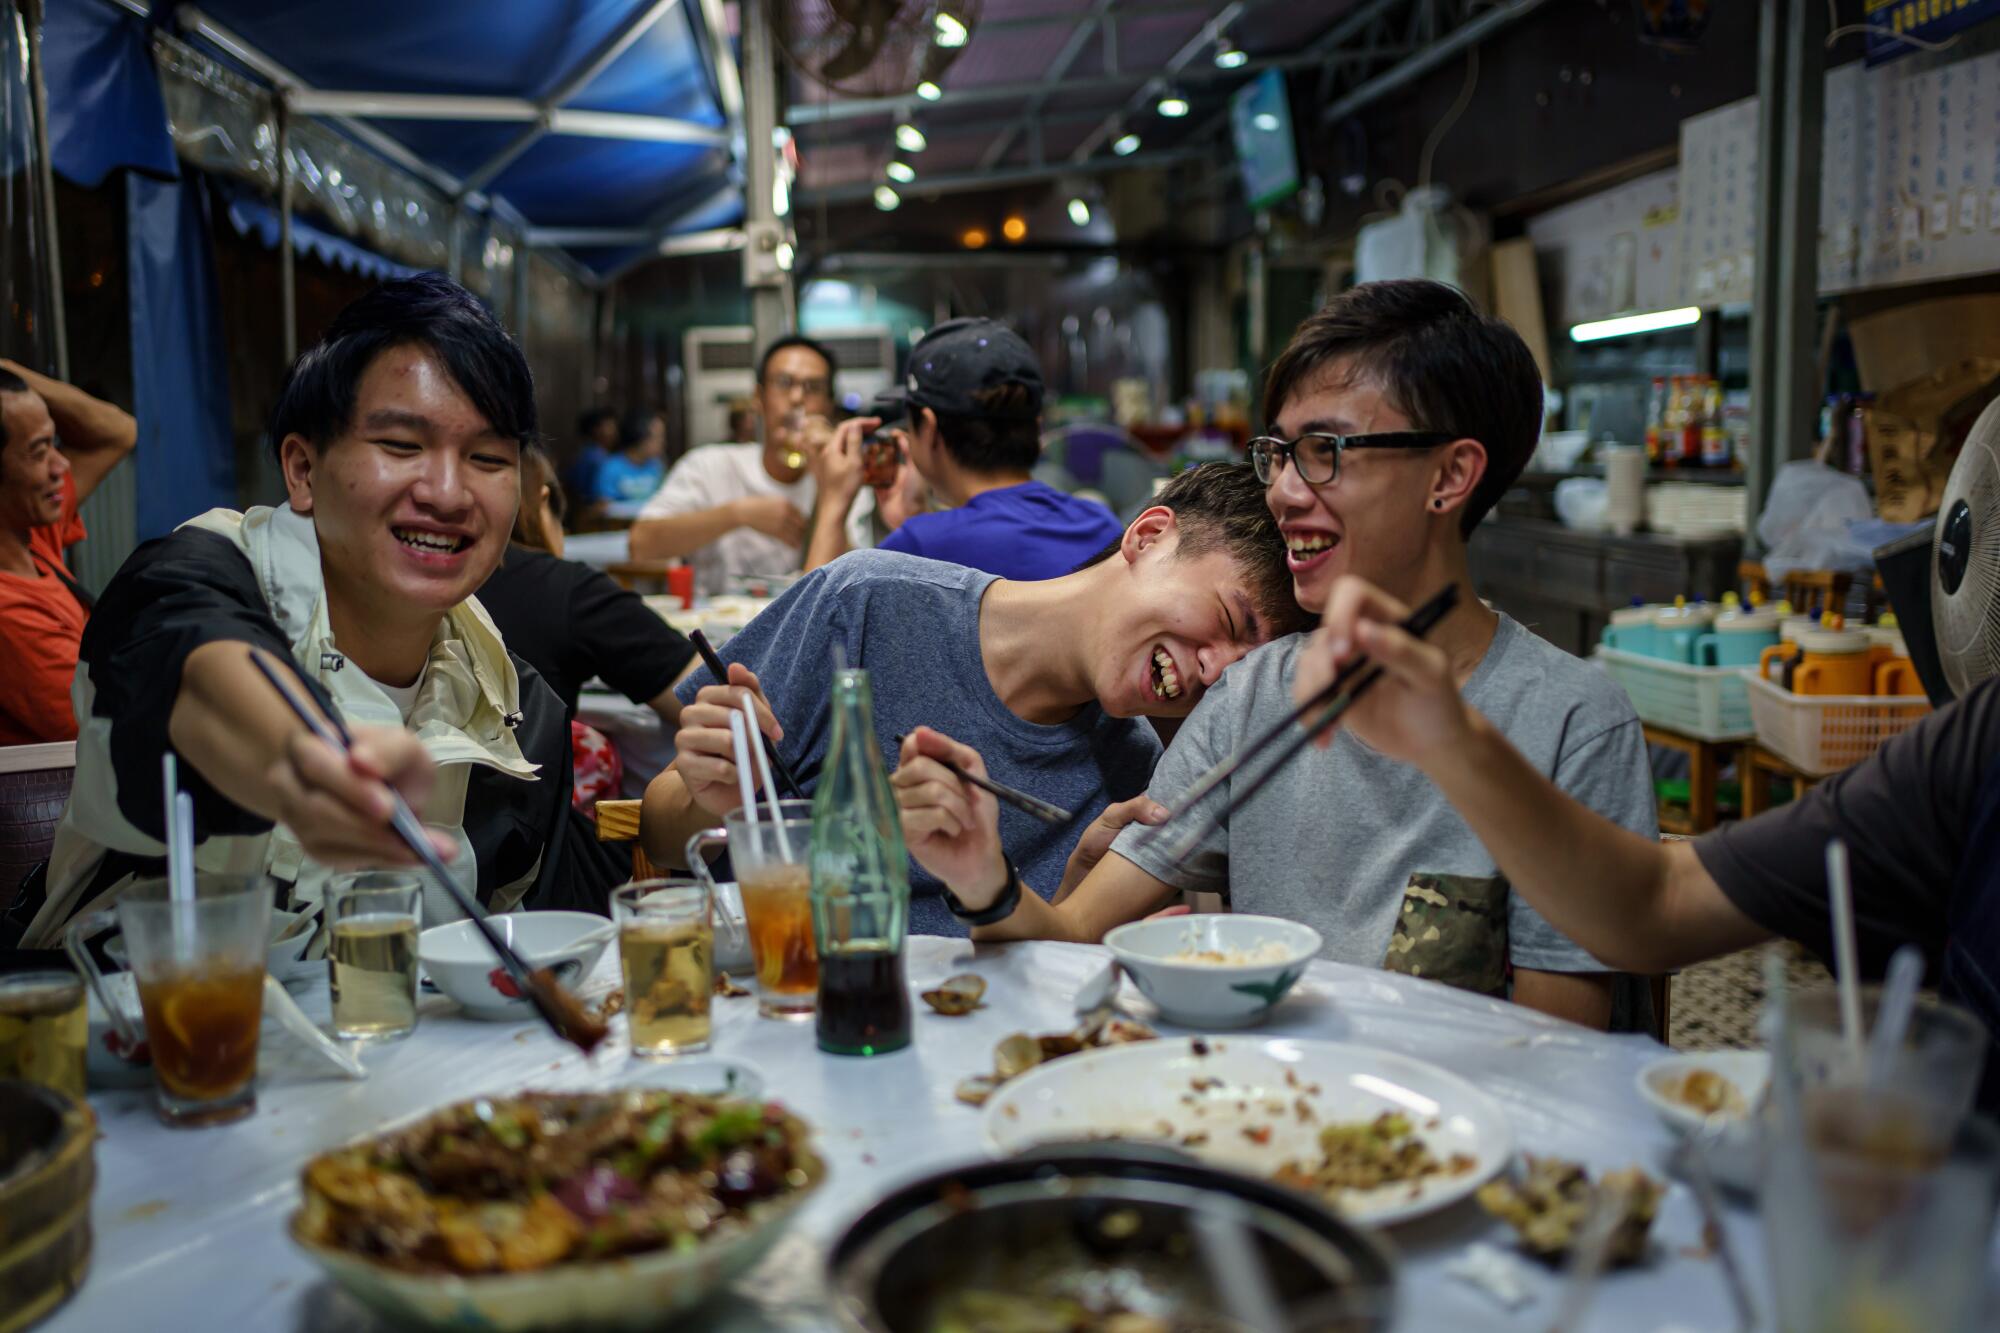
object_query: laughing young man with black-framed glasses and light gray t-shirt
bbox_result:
[894,280,1658,1027]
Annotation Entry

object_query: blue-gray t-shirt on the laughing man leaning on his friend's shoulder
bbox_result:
[676,550,1160,935]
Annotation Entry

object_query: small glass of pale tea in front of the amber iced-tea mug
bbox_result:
[612,879,716,1059]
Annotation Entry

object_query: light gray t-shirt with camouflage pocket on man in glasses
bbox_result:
[1112,614,1660,995]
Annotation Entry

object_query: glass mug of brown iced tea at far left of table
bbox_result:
[64,875,274,1125]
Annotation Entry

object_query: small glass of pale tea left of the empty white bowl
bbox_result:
[326,871,424,1041]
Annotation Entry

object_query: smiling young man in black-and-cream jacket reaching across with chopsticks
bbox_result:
[22,274,580,949]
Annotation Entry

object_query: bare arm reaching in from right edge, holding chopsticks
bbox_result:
[1294,576,1768,973]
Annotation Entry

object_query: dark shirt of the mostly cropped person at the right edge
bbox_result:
[1694,679,2000,977]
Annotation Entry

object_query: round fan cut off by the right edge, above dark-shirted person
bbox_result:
[1930,400,2000,697]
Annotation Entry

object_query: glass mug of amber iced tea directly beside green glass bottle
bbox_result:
[688,801,820,1019]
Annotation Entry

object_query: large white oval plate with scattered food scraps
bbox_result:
[986,1037,1514,1227]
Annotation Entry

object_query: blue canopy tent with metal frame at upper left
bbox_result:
[29,0,744,560]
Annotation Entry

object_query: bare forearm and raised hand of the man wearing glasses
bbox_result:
[890,727,1174,945]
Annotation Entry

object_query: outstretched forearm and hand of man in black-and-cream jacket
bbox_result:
[168,640,458,869]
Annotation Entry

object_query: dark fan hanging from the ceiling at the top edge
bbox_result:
[776,0,982,98]
